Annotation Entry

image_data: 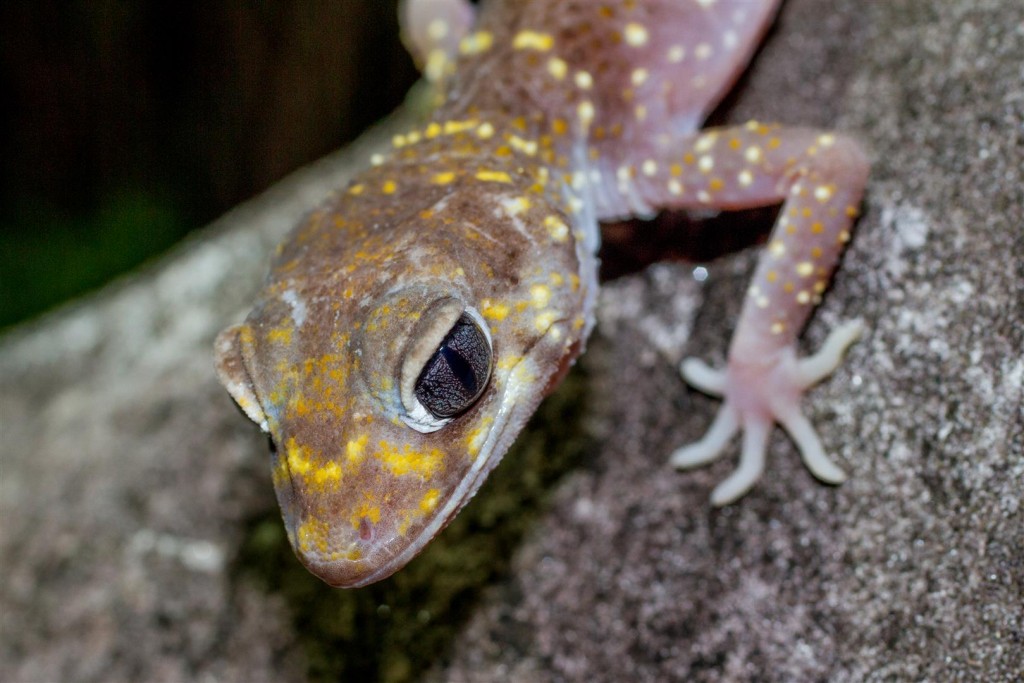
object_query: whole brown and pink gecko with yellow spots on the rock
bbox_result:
[214,0,868,588]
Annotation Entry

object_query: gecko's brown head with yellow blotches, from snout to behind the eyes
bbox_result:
[216,183,588,587]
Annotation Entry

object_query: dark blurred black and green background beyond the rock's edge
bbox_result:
[0,0,416,329]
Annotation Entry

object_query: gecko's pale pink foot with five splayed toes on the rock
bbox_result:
[670,321,864,506]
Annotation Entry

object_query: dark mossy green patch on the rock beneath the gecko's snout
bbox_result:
[238,370,587,683]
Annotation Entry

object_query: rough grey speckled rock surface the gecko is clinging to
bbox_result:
[0,0,1024,682]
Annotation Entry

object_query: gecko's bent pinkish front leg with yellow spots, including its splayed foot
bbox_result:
[615,122,867,505]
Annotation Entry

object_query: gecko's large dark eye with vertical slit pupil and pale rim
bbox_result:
[402,305,493,432]
